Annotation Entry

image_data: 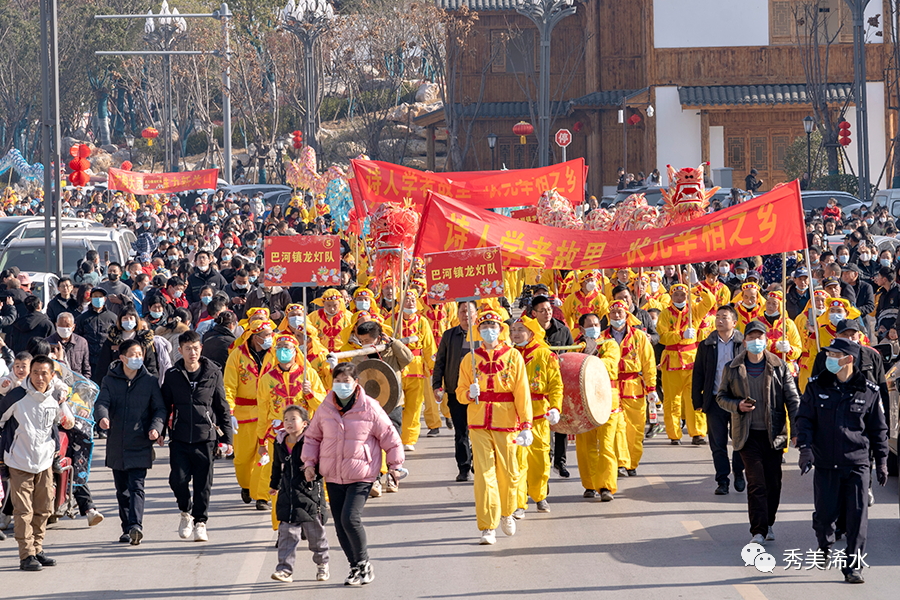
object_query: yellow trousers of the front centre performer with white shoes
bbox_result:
[469,429,519,531]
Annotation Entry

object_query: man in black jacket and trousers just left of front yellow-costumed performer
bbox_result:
[431,302,478,481]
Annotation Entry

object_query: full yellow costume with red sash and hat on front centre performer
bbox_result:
[456,311,532,531]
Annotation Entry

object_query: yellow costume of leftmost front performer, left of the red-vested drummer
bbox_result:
[225,320,275,501]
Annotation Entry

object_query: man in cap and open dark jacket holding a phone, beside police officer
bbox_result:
[716,321,808,544]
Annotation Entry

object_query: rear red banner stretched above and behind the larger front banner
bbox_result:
[350,158,587,212]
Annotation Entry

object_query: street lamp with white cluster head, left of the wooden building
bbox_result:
[278,0,334,156]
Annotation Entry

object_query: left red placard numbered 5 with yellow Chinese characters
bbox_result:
[263,235,341,287]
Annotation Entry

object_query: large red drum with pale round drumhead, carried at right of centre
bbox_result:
[550,352,612,434]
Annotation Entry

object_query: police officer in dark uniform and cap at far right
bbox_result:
[797,338,888,583]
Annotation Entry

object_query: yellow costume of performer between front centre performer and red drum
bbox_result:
[517,317,563,509]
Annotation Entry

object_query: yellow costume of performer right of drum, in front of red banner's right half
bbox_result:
[656,283,716,440]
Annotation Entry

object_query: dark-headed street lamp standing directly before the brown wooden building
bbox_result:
[516,0,575,167]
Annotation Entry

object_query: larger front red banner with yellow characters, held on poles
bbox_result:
[414,181,806,269]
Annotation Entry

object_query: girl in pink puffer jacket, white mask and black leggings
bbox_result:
[301,363,404,585]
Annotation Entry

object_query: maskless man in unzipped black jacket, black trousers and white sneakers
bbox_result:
[162,331,232,542]
